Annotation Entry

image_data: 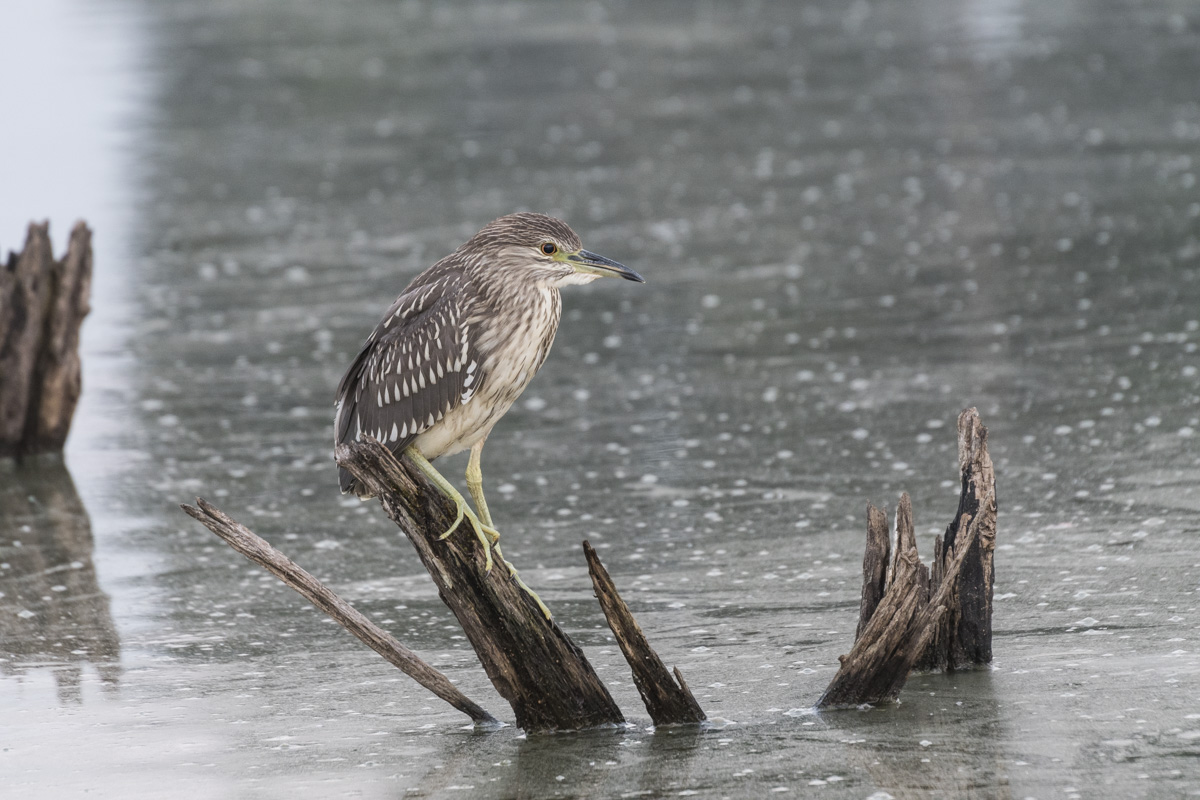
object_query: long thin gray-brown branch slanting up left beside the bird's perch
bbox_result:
[180,498,498,724]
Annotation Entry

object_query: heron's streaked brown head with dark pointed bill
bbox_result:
[462,212,646,289]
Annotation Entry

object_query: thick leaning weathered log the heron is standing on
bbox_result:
[336,440,624,733]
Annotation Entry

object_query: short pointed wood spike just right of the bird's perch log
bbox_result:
[583,541,708,727]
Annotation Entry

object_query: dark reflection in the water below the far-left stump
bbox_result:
[0,457,120,703]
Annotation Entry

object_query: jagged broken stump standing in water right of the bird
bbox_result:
[817,408,996,708]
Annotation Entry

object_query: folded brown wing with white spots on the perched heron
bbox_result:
[335,273,480,493]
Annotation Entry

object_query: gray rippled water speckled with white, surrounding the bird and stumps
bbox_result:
[0,0,1200,800]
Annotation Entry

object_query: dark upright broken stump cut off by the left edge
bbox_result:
[0,222,92,457]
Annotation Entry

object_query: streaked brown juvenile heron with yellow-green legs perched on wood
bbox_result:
[334,212,646,619]
